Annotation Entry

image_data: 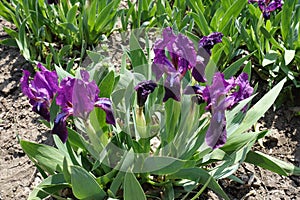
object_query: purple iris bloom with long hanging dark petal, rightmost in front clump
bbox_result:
[185,72,253,149]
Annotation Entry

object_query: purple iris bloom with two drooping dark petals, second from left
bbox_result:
[52,70,115,142]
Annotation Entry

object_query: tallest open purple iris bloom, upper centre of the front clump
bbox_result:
[152,27,196,102]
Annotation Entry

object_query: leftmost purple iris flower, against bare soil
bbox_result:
[20,63,58,121]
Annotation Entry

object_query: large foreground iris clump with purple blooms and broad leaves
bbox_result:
[20,28,300,200]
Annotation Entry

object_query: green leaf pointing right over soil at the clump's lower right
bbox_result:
[245,151,300,176]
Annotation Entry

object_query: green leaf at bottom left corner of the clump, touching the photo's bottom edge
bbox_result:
[28,174,70,200]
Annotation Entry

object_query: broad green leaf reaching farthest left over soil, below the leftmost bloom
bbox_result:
[20,140,64,174]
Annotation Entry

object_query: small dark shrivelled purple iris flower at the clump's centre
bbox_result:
[134,80,157,107]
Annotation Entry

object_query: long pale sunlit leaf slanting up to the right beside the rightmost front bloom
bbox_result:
[232,79,286,134]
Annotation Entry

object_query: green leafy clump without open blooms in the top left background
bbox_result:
[0,0,120,67]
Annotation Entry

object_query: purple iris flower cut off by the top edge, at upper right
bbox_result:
[248,0,283,19]
